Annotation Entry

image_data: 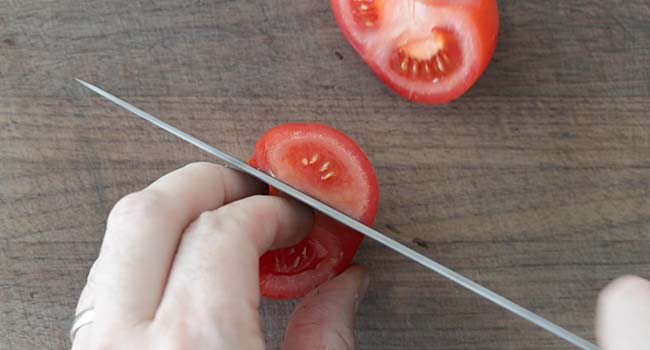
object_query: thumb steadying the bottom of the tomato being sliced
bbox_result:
[283,265,368,350]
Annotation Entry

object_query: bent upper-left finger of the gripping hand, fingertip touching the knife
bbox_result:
[94,163,264,327]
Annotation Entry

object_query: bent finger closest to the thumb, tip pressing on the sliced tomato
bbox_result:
[154,196,313,349]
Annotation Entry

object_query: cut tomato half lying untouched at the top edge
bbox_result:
[332,0,499,103]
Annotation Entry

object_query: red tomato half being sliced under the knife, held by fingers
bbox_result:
[250,123,379,299]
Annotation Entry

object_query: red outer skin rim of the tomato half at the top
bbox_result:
[331,0,499,104]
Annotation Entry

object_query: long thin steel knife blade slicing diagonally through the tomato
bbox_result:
[75,79,598,350]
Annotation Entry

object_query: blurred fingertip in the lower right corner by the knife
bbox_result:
[596,276,650,350]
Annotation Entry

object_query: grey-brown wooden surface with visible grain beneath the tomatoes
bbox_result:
[0,0,650,350]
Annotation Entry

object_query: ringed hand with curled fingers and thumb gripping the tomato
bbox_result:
[73,163,368,350]
